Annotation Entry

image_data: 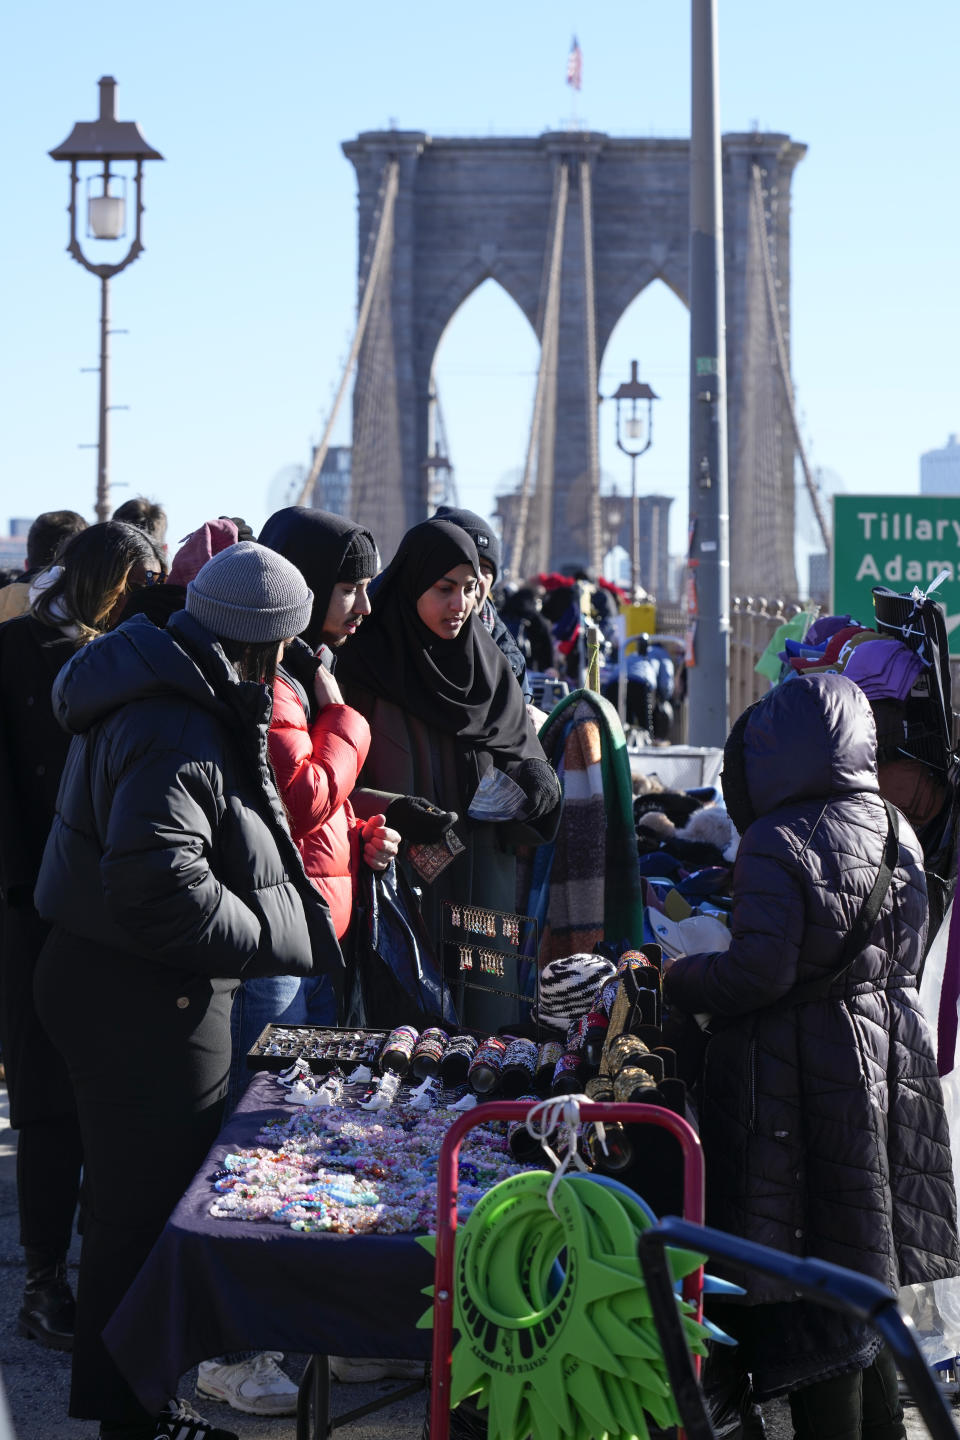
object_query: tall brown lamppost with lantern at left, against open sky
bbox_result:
[49,75,163,520]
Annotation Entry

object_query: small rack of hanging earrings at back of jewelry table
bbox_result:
[442,900,538,1004]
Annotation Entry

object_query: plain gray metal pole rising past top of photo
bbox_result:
[687,0,731,744]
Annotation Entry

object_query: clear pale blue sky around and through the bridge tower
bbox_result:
[0,0,960,584]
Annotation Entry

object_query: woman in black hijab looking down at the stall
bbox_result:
[340,520,561,1025]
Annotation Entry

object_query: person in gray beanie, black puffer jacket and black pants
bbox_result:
[35,543,343,1440]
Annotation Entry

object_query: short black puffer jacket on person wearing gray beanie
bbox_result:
[36,611,343,979]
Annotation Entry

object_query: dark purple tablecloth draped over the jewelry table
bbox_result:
[104,1074,433,1411]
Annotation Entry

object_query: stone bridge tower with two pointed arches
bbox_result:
[344,131,805,593]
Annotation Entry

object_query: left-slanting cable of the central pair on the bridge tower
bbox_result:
[511,160,570,577]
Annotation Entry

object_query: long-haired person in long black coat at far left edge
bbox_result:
[0,524,157,1349]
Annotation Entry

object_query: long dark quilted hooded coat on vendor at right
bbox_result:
[665,675,960,1302]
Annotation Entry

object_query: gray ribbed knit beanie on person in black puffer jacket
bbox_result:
[186,540,314,645]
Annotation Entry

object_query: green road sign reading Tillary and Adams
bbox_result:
[833,495,960,654]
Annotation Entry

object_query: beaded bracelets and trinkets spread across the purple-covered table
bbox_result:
[210,948,685,1234]
